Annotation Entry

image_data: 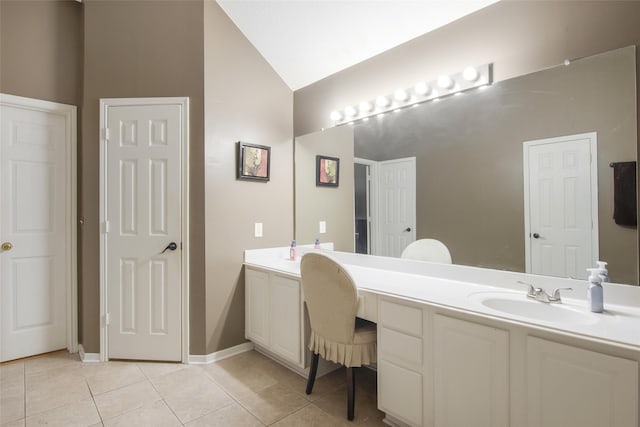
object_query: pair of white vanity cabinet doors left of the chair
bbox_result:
[245,267,304,368]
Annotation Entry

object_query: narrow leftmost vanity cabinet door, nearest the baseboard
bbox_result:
[244,268,269,347]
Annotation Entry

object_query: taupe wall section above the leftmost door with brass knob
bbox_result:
[0,0,82,105]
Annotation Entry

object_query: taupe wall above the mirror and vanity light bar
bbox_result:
[294,0,640,283]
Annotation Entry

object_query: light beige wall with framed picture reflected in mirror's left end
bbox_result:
[295,126,355,252]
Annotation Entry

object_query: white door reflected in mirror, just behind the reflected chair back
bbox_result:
[376,157,416,257]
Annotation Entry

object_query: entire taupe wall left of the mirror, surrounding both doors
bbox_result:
[0,0,293,354]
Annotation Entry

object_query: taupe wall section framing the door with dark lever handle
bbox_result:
[79,0,205,354]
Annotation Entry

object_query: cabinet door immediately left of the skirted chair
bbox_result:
[270,275,302,364]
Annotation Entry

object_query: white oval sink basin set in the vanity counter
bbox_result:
[472,294,598,324]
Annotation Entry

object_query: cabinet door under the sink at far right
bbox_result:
[527,337,638,427]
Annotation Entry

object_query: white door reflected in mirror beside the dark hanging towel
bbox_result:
[524,133,598,278]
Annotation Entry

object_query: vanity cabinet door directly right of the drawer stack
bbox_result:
[433,314,509,427]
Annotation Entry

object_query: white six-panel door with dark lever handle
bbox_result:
[103,100,187,361]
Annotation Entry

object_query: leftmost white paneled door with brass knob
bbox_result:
[0,95,75,361]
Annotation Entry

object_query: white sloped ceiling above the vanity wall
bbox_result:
[216,0,497,90]
